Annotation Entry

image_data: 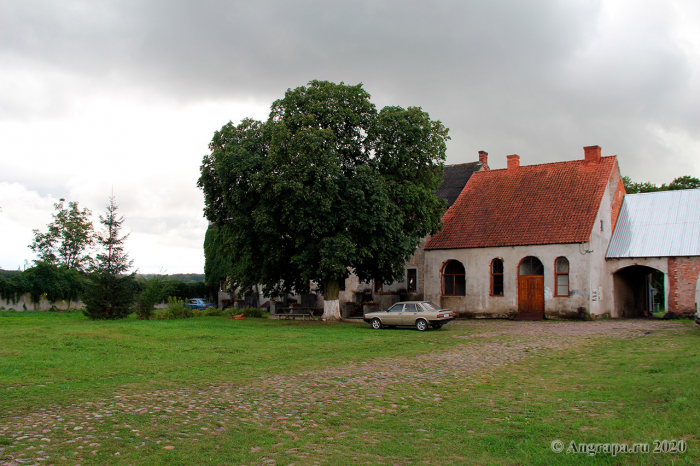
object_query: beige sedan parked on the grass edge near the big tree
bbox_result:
[362,301,455,332]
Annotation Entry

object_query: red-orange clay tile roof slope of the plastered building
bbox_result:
[425,156,615,249]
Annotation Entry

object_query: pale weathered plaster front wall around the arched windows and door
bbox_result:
[424,243,604,317]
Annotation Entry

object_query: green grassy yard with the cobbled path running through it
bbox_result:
[0,312,700,465]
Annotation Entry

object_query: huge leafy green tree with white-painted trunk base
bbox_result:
[198,81,449,319]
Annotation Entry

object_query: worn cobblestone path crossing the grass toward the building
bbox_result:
[0,319,688,466]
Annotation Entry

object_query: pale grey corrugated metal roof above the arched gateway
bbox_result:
[606,189,700,258]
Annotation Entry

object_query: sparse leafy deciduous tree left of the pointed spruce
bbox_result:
[29,199,94,271]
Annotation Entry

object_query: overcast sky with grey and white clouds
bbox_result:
[0,0,700,273]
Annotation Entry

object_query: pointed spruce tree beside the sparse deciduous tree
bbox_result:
[83,196,137,319]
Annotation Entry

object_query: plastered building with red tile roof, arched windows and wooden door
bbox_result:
[424,146,625,318]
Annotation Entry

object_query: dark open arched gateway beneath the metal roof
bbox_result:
[613,265,666,317]
